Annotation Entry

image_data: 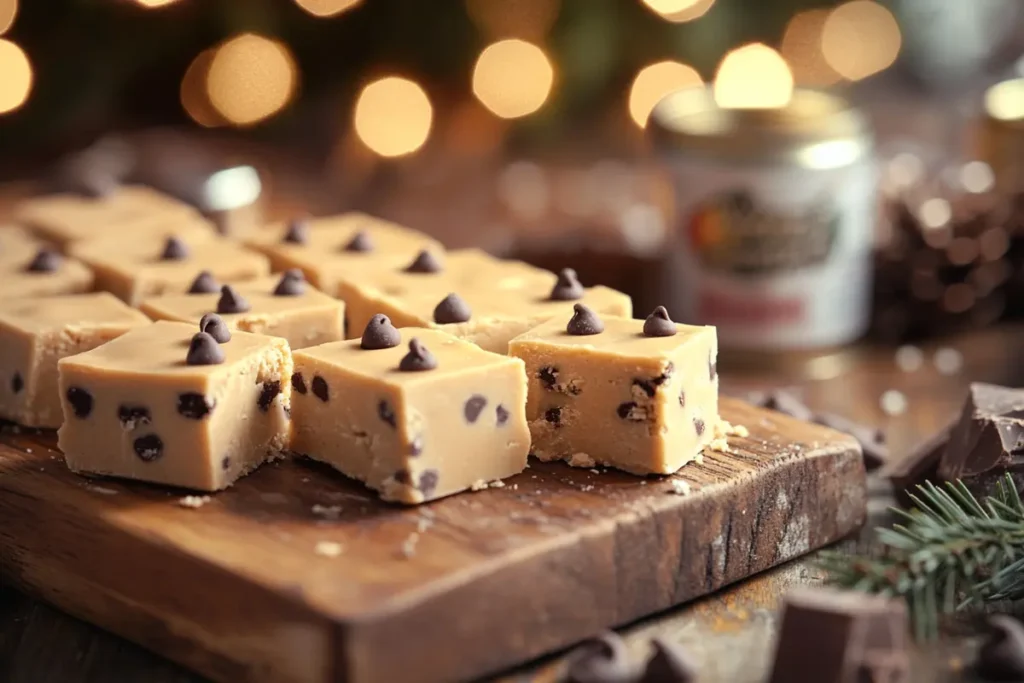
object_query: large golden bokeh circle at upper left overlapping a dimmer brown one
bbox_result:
[206,33,298,126]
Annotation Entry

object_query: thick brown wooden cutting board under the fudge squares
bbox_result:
[0,398,866,683]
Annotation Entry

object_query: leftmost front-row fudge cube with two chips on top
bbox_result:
[57,317,292,490]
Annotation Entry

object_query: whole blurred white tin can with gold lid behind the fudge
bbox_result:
[649,88,878,352]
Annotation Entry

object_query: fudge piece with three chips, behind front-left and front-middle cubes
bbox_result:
[140,270,345,349]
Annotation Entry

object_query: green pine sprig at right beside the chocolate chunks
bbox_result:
[821,474,1024,640]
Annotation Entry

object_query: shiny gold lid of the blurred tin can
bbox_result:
[648,88,872,169]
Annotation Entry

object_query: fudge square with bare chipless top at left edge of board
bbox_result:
[0,292,150,428]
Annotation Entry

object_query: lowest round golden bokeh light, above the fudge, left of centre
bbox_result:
[354,76,434,157]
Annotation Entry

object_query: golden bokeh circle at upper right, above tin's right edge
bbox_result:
[821,0,902,81]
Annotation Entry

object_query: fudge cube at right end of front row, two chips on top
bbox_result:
[509,304,718,474]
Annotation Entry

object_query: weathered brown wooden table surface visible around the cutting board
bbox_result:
[0,326,1024,683]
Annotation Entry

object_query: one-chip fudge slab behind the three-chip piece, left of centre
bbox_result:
[71,232,270,306]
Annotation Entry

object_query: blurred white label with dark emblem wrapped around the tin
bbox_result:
[670,160,877,350]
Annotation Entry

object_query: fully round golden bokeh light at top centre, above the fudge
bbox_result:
[473,38,555,119]
